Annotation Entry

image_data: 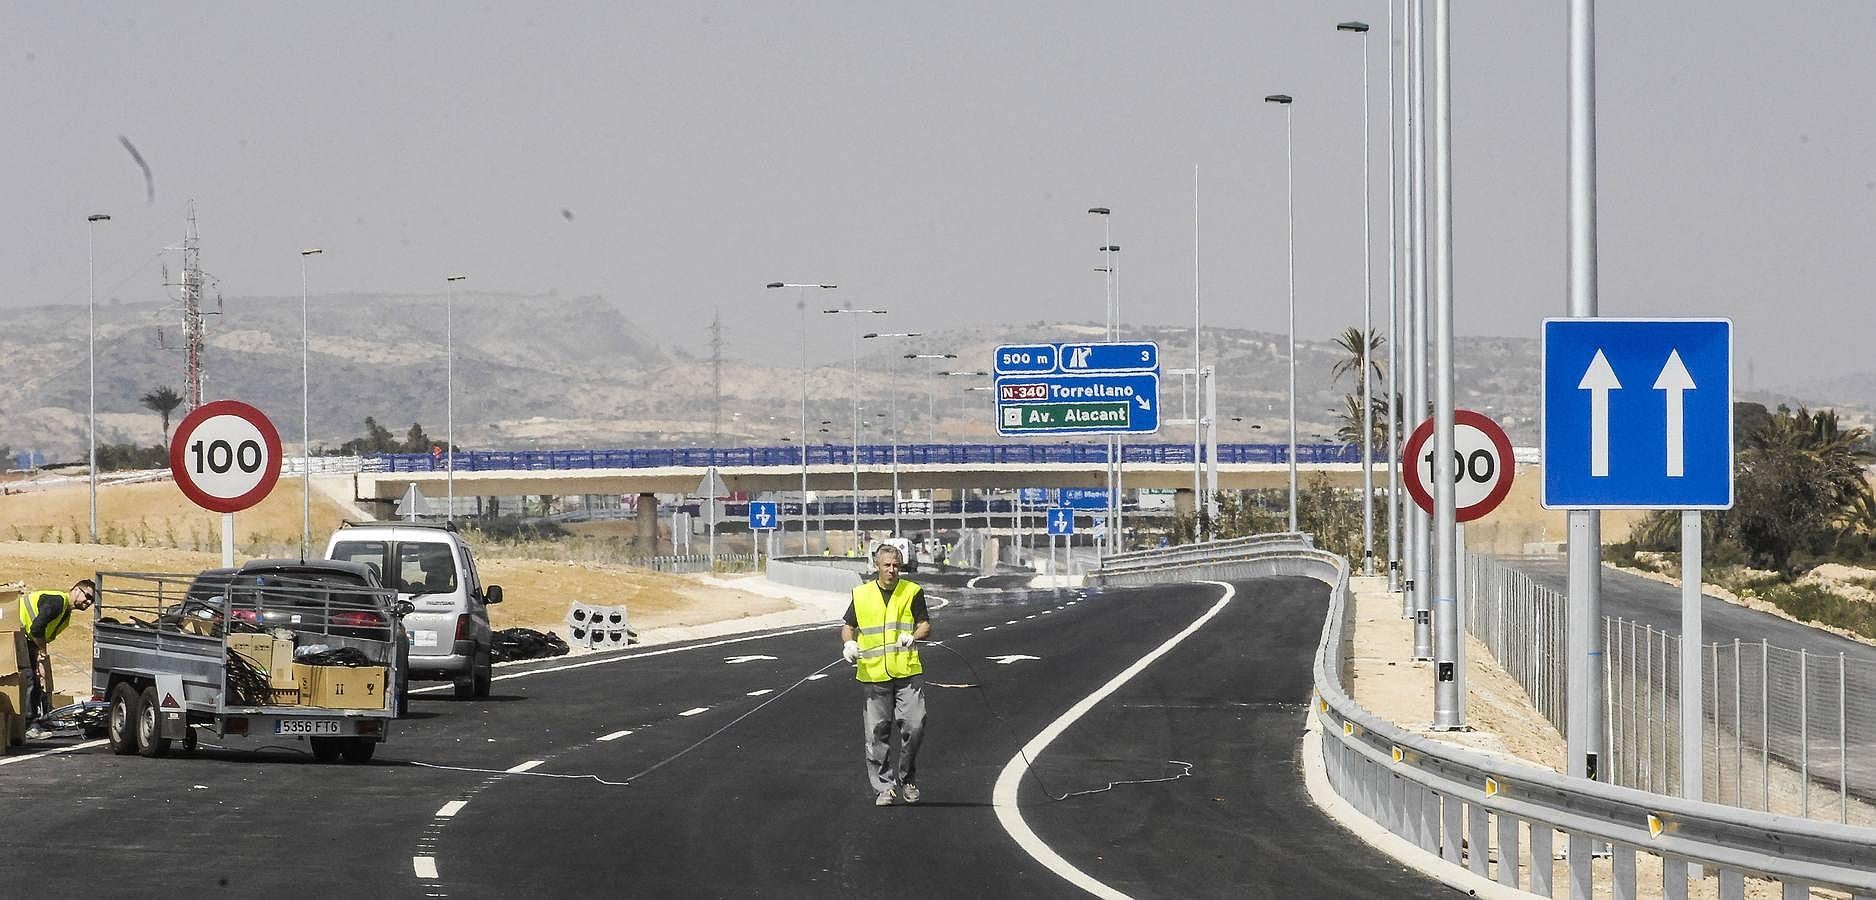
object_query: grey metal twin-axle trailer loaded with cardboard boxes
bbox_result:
[92,572,401,763]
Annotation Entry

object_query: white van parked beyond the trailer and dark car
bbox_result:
[326,521,501,699]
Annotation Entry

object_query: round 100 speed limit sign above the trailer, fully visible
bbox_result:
[169,399,280,512]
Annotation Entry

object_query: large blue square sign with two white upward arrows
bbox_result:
[1542,319,1733,510]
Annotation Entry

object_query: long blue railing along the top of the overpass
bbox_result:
[364,444,1362,473]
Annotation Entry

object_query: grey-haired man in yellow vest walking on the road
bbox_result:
[840,544,932,806]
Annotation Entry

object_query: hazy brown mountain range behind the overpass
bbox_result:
[0,294,1876,459]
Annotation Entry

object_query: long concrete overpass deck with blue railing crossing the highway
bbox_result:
[353,443,1386,514]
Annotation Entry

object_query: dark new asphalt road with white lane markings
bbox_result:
[0,579,1446,898]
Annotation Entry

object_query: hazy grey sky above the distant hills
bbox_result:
[11,0,1876,384]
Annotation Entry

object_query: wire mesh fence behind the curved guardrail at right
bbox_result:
[1463,557,1876,825]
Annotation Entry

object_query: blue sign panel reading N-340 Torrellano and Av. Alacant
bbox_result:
[996,371,1159,435]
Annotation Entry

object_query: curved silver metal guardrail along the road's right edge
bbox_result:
[1096,540,1876,900]
